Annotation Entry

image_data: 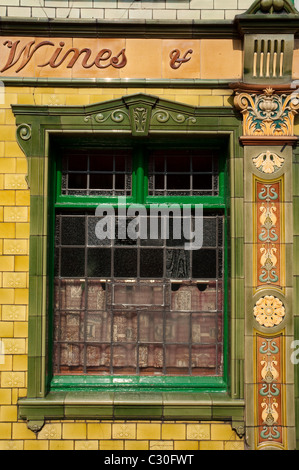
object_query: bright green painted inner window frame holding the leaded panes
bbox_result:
[48,141,228,392]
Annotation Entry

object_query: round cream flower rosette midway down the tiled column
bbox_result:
[253,295,285,328]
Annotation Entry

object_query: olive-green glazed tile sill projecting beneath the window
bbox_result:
[18,391,245,435]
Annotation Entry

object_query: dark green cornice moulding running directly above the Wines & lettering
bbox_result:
[0,17,240,39]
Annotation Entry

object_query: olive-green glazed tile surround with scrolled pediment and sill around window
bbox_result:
[12,94,244,435]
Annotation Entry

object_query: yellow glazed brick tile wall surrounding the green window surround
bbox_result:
[0,87,244,450]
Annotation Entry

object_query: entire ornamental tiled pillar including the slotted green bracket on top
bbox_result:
[232,0,299,450]
